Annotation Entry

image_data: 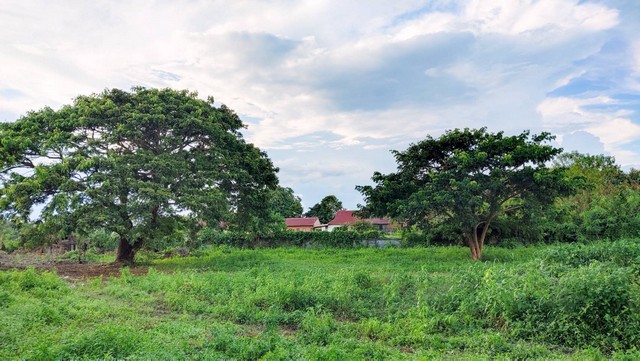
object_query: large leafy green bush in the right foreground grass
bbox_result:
[458,241,640,352]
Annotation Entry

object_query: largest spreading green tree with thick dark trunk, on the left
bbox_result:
[0,88,277,263]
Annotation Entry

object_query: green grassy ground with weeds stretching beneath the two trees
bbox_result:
[0,241,640,360]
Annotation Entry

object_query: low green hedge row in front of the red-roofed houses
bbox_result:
[199,229,381,248]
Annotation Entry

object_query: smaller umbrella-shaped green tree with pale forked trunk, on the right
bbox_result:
[357,128,571,260]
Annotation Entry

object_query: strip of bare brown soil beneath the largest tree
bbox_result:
[0,252,147,280]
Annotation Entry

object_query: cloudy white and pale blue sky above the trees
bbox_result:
[0,0,640,209]
